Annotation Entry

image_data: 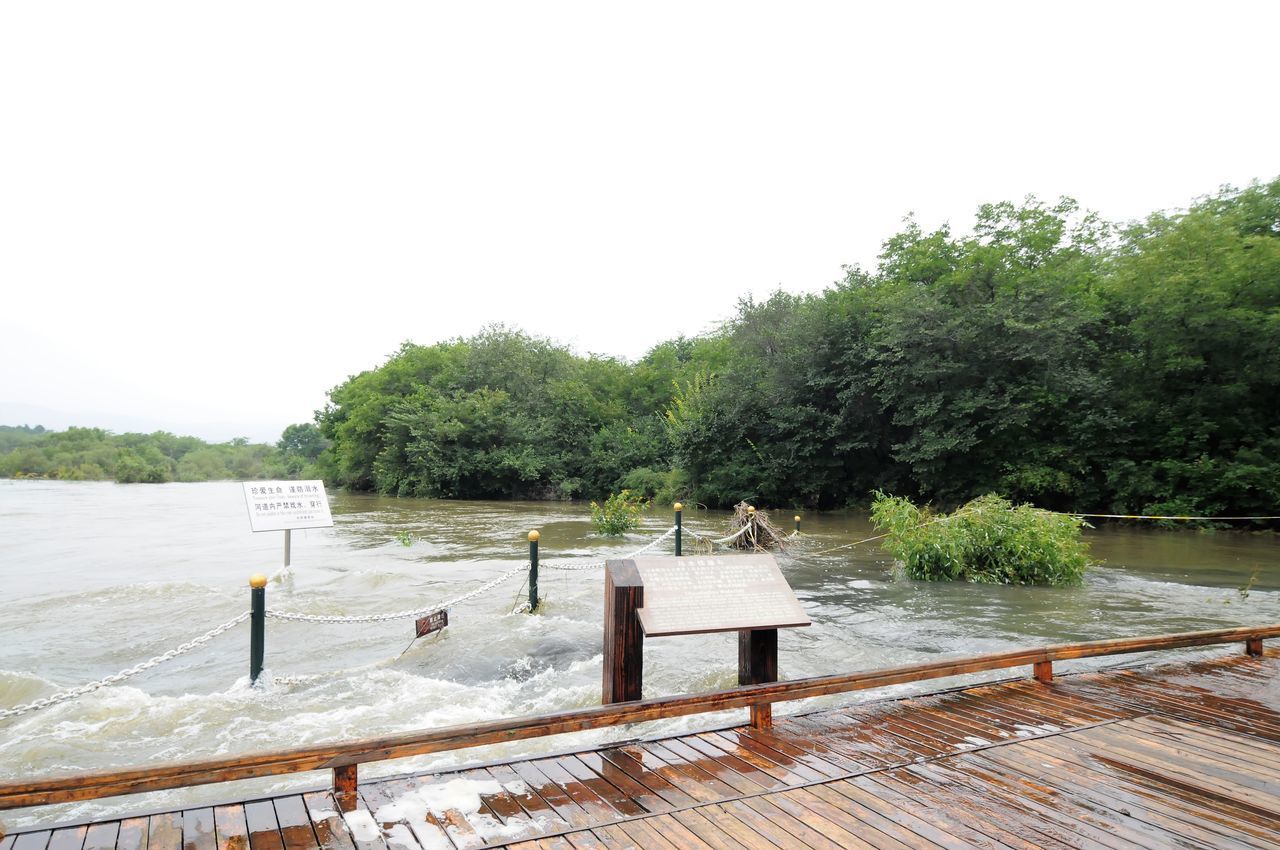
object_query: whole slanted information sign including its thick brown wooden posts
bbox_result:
[602,554,812,728]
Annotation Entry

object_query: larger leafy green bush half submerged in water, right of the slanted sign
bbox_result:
[872,493,1091,585]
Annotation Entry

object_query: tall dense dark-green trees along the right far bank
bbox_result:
[317,179,1280,515]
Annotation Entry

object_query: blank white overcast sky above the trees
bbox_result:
[0,0,1280,440]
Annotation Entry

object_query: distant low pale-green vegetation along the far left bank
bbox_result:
[0,422,325,484]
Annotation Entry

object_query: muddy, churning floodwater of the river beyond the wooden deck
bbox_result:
[0,481,1280,824]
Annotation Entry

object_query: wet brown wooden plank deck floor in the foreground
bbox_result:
[0,649,1280,850]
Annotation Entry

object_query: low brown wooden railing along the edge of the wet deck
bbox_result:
[0,625,1280,809]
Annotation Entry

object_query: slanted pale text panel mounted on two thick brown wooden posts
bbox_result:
[635,554,812,638]
